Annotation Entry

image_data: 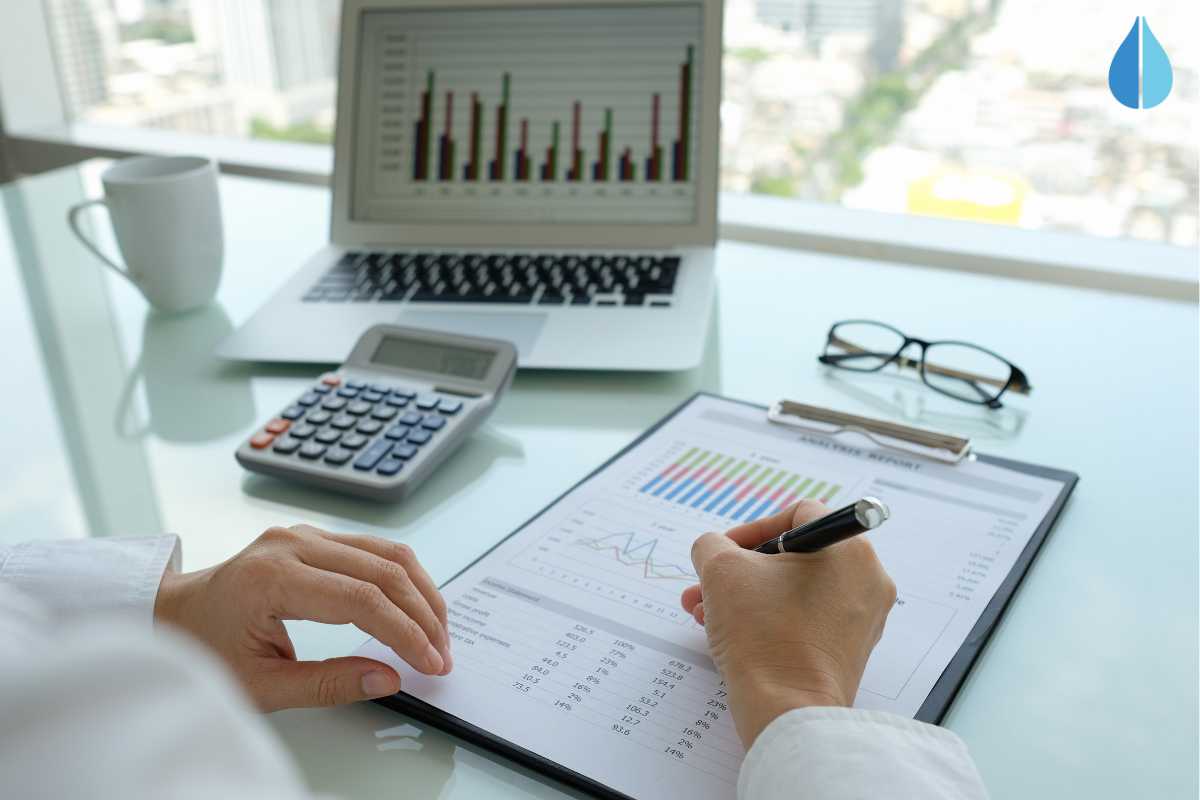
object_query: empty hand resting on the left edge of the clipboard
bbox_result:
[154,525,452,711]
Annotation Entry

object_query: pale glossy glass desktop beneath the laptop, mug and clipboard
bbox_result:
[0,162,1200,799]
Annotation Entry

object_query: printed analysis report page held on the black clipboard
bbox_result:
[359,396,1061,800]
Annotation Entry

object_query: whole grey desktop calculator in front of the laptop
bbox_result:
[235,325,517,500]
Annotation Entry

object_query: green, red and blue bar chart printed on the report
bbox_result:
[638,446,842,522]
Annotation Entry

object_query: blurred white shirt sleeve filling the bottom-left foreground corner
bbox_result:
[0,584,310,800]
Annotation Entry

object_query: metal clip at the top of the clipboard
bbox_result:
[767,399,972,464]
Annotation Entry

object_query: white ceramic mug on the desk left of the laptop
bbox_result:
[67,156,224,312]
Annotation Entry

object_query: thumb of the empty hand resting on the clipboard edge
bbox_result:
[253,656,400,711]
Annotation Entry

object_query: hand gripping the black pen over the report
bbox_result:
[683,500,896,750]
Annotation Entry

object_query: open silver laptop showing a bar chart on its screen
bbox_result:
[218,0,721,371]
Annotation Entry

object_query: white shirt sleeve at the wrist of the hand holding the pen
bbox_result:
[738,708,988,800]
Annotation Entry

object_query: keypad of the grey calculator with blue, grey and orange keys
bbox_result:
[250,374,463,477]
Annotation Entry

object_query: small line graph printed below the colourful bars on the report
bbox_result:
[511,500,704,625]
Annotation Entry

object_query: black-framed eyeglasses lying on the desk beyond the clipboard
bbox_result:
[817,319,1032,408]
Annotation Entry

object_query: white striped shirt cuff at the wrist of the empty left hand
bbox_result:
[0,535,180,625]
